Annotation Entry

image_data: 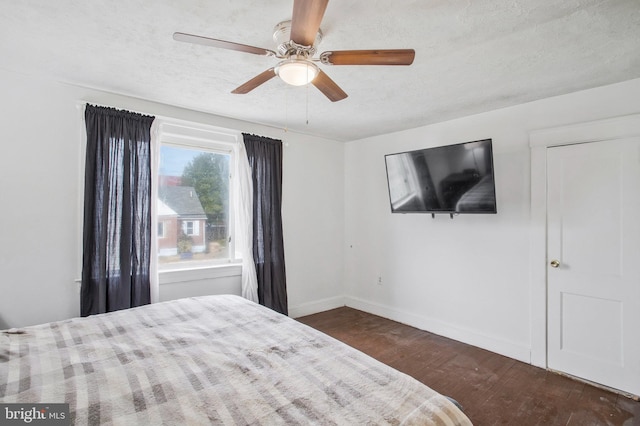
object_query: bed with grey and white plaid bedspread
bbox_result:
[0,295,471,425]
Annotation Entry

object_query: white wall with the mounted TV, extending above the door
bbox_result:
[345,79,640,362]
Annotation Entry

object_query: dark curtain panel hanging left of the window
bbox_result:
[80,105,154,316]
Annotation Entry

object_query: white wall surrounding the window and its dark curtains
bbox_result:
[0,70,344,329]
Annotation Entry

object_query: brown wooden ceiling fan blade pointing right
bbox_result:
[320,49,416,65]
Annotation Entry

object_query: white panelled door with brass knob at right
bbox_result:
[547,138,640,395]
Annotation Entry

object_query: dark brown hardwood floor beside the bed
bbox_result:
[297,307,640,426]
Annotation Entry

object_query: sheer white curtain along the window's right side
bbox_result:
[235,140,258,303]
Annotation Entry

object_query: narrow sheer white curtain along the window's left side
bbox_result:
[149,120,160,303]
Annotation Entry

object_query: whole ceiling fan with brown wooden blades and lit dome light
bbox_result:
[173,0,415,102]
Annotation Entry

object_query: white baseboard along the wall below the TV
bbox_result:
[344,296,531,364]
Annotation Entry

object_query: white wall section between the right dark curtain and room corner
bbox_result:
[282,131,344,317]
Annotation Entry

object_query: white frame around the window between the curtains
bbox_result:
[152,120,242,272]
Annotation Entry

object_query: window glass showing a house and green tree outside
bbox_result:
[158,144,231,269]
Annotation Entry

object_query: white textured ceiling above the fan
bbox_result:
[0,0,640,141]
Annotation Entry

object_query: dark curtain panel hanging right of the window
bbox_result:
[242,133,288,315]
